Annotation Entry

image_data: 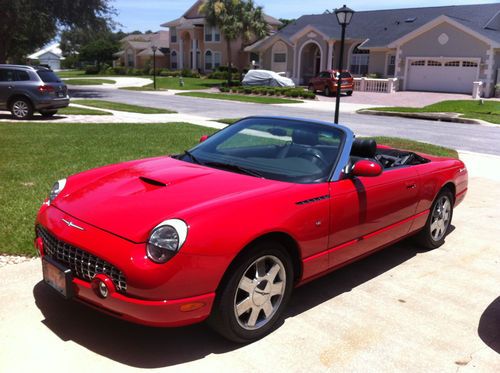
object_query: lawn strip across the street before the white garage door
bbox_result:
[370,100,500,124]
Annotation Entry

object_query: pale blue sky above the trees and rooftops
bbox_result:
[112,0,495,32]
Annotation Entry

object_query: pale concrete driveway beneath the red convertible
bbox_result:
[0,153,500,372]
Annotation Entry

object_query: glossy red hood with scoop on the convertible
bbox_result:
[53,157,290,242]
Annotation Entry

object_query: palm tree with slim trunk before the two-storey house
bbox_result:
[199,0,267,85]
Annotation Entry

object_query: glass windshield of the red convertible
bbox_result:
[178,118,345,183]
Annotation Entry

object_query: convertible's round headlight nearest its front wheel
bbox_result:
[146,219,188,263]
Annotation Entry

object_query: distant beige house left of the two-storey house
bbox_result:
[113,31,170,69]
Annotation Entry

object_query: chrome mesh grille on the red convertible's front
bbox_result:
[36,226,127,293]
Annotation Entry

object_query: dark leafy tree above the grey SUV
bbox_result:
[0,0,114,63]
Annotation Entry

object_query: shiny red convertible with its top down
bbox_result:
[35,117,467,342]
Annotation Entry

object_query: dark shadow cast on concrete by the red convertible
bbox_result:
[33,240,428,368]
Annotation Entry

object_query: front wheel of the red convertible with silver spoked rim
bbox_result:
[208,242,294,343]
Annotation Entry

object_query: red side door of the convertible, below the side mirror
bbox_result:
[328,166,419,267]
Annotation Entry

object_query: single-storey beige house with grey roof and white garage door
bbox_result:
[245,3,500,97]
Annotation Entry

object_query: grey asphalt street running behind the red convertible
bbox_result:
[71,88,500,155]
